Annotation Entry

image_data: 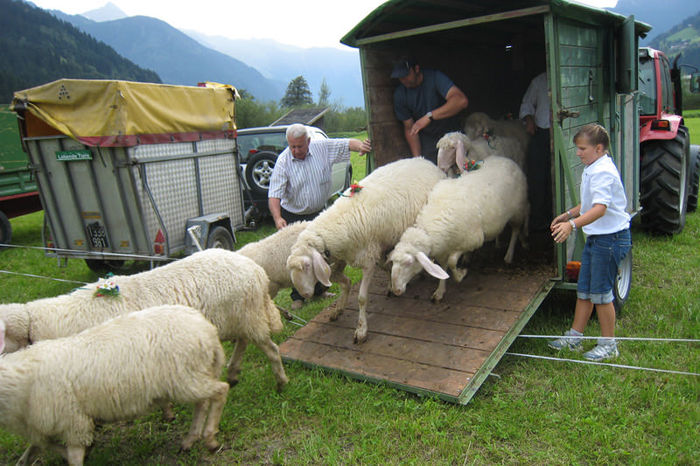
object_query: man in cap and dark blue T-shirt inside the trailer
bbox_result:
[391,58,469,163]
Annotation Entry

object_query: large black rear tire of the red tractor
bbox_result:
[640,126,690,235]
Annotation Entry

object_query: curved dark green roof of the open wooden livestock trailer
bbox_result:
[340,0,651,47]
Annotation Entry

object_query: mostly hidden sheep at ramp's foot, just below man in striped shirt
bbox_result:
[238,221,350,299]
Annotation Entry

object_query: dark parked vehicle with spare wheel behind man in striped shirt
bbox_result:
[238,125,352,221]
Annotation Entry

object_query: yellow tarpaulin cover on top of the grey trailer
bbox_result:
[12,79,236,146]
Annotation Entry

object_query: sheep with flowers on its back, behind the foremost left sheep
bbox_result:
[0,249,287,390]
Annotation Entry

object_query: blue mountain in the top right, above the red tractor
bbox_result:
[608,0,700,46]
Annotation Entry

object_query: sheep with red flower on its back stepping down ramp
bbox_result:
[287,158,445,343]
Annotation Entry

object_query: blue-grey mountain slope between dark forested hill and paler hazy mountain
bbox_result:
[52,10,283,101]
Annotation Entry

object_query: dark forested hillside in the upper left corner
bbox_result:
[0,0,161,103]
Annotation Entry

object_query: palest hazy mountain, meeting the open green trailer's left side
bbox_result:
[186,31,365,107]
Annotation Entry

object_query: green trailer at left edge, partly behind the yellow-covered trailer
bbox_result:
[0,105,41,249]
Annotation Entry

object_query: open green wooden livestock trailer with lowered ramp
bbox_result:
[282,0,650,404]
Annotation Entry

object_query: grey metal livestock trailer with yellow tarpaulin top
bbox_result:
[12,79,244,273]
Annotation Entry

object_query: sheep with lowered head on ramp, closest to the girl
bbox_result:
[388,156,529,302]
